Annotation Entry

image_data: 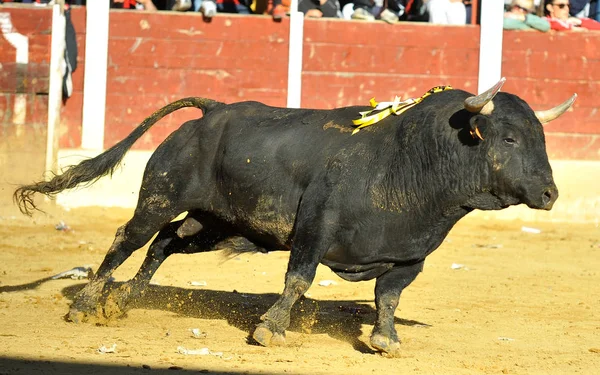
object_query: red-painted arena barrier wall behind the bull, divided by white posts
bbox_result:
[0,8,600,160]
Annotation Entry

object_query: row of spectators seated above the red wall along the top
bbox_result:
[0,0,600,32]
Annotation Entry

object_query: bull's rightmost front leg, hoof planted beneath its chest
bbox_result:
[371,262,423,357]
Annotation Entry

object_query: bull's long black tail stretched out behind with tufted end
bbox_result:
[13,97,221,216]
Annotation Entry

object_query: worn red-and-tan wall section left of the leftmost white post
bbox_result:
[0,7,51,195]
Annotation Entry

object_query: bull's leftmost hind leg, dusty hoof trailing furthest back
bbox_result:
[67,199,181,323]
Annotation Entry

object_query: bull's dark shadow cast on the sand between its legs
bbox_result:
[62,283,429,353]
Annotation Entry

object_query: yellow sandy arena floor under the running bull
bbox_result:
[0,201,600,374]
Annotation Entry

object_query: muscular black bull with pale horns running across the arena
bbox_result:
[14,80,575,355]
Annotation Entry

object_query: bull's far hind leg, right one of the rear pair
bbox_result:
[104,218,229,318]
